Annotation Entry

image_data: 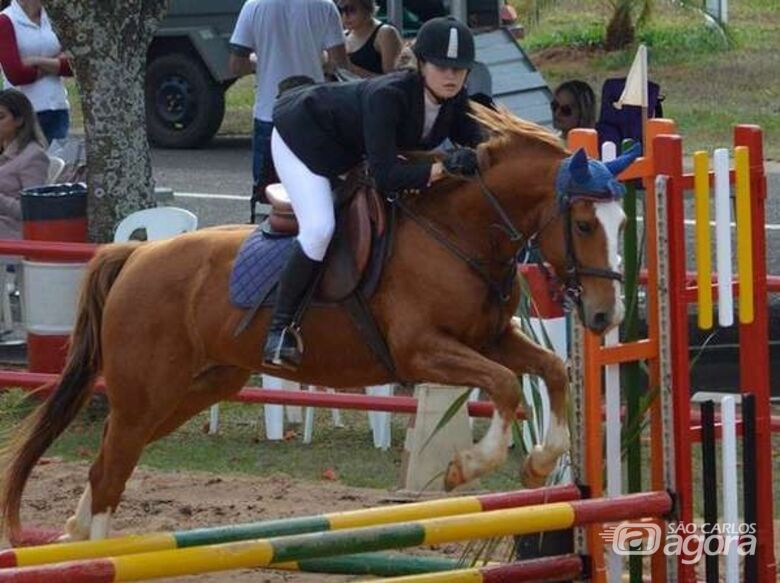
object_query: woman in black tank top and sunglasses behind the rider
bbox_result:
[339,0,403,77]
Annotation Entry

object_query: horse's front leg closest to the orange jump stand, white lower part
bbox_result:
[487,318,571,488]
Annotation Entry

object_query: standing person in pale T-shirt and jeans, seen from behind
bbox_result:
[229,0,348,222]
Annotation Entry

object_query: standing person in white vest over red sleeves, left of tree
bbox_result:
[0,0,73,142]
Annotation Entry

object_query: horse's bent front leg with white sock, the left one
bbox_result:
[401,336,520,490]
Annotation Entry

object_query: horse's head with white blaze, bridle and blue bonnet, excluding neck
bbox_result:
[538,143,639,334]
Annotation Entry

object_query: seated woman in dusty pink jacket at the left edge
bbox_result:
[0,89,49,239]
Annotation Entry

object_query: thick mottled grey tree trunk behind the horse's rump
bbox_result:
[44,0,169,243]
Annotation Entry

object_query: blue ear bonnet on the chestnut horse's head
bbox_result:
[555,143,642,209]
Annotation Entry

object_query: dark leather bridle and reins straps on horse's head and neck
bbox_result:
[388,171,623,310]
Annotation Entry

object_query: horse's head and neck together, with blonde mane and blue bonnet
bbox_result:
[458,104,639,334]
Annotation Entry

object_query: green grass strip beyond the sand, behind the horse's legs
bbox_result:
[0,391,520,491]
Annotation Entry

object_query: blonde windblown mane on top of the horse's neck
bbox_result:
[471,102,567,155]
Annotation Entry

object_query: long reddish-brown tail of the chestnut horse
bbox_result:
[0,243,137,539]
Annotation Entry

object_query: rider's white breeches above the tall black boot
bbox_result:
[271,129,336,261]
